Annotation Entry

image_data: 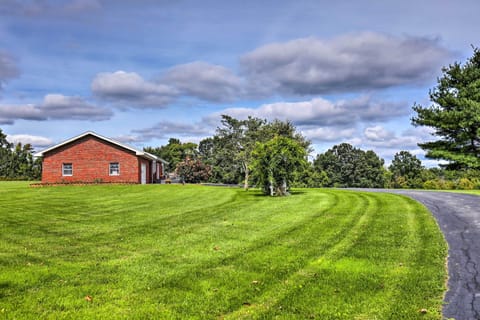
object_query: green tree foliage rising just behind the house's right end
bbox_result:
[144,138,198,172]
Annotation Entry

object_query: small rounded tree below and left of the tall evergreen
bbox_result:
[388,151,423,188]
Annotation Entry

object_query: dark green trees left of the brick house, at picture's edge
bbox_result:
[0,129,42,180]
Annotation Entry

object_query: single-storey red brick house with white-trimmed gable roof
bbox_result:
[35,131,167,184]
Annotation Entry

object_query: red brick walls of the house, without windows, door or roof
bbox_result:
[42,136,146,183]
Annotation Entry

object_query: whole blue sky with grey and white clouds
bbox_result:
[0,0,480,166]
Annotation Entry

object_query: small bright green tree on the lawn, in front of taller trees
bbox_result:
[251,136,308,196]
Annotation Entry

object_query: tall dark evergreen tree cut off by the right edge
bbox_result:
[412,48,480,169]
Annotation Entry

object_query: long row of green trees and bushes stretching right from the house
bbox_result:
[145,115,480,195]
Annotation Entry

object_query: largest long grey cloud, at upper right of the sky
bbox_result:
[241,32,451,94]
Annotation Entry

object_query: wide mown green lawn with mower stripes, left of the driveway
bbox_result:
[0,182,447,319]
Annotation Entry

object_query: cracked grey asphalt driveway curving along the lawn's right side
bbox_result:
[368,190,480,320]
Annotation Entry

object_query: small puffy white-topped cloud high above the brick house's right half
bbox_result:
[91,71,178,108]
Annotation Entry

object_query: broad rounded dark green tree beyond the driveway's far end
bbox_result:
[314,143,385,188]
